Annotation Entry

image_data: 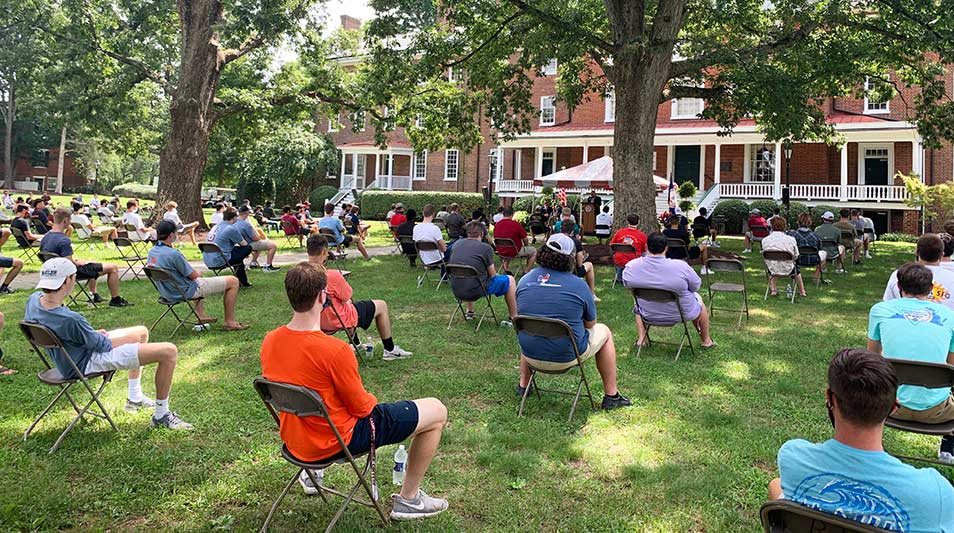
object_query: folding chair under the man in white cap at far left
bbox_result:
[20,320,119,453]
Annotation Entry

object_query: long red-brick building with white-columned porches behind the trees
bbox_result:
[326,17,954,233]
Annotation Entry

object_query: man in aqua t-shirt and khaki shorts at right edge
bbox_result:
[868,263,954,464]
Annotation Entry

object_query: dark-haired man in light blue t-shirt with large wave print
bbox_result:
[769,348,954,533]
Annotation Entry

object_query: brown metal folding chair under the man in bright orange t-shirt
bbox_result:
[254,377,389,533]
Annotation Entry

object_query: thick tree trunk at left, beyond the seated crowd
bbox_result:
[154,0,225,227]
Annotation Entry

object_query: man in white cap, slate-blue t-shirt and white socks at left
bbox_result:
[24,257,192,430]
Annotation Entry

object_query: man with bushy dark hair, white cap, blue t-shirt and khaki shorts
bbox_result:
[517,233,631,409]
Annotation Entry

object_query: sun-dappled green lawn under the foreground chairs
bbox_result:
[0,239,954,532]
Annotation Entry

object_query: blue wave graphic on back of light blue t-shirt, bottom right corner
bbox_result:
[792,473,911,533]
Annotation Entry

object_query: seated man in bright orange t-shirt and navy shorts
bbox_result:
[261,263,447,520]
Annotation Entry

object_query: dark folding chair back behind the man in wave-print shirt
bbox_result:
[759,500,889,533]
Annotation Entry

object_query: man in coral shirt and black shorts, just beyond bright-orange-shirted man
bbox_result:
[307,235,414,361]
